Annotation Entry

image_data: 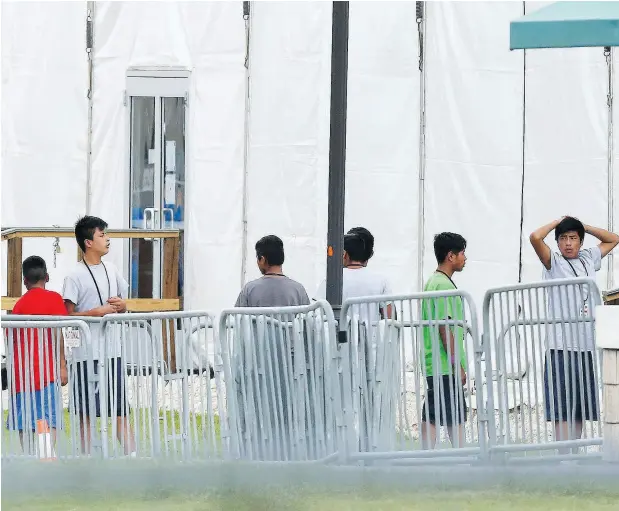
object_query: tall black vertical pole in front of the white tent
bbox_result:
[327,2,348,340]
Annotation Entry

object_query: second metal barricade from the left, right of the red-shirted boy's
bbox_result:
[101,311,220,460]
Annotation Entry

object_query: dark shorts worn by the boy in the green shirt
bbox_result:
[421,374,468,426]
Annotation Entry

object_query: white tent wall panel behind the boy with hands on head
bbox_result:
[523,2,607,292]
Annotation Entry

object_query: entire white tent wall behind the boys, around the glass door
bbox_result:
[1,1,619,316]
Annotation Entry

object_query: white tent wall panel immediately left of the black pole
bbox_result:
[247,2,331,295]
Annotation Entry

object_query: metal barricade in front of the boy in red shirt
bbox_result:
[2,315,95,459]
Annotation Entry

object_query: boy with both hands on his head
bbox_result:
[529,216,619,453]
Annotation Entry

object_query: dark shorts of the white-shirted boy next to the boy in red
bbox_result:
[73,358,129,417]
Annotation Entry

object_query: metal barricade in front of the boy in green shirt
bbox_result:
[340,290,487,464]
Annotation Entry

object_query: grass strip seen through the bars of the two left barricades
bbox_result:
[2,408,221,456]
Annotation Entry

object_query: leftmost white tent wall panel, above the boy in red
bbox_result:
[1,2,88,294]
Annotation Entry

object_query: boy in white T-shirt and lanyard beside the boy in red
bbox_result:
[62,216,135,456]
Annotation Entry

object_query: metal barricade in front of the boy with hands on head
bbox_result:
[483,278,602,463]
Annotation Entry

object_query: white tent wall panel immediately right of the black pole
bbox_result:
[345,2,420,293]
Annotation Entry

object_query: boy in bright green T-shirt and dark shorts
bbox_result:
[421,232,467,449]
